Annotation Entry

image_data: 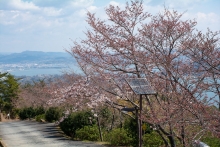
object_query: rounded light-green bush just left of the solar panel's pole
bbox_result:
[105,128,132,146]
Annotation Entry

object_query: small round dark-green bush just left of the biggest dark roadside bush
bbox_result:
[45,107,62,122]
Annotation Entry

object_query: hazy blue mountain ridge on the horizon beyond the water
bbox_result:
[0,51,75,64]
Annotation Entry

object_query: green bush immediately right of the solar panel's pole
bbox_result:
[143,132,164,147]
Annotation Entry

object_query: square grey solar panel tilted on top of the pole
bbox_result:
[126,78,156,95]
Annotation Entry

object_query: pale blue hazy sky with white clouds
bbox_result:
[0,0,220,52]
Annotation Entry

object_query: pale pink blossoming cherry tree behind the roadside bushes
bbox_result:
[45,74,108,111]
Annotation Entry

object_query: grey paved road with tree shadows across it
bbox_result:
[0,121,104,147]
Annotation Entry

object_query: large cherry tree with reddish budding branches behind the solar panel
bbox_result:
[70,0,220,147]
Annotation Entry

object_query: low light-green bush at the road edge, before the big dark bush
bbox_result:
[76,125,99,141]
